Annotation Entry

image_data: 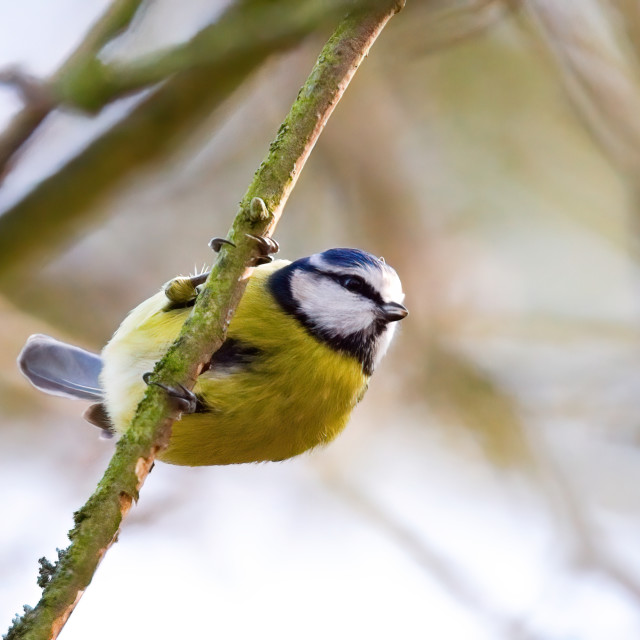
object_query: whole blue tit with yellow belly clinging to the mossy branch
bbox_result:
[18,249,407,466]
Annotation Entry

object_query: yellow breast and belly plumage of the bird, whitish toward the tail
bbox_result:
[102,262,367,466]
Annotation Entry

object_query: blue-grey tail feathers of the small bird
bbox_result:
[18,334,103,401]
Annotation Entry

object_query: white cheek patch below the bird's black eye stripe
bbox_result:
[291,271,376,336]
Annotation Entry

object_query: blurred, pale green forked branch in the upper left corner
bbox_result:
[0,0,367,184]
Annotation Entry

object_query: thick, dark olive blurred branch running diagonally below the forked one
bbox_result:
[0,0,380,292]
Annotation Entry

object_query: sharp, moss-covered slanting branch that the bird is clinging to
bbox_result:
[6,0,403,640]
